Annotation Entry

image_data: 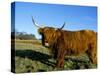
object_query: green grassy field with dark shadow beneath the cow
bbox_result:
[11,40,96,73]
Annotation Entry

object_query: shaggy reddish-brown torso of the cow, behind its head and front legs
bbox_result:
[61,30,97,55]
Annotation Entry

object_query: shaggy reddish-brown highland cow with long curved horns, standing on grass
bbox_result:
[32,19,97,68]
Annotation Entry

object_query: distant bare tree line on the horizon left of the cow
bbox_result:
[11,32,36,40]
